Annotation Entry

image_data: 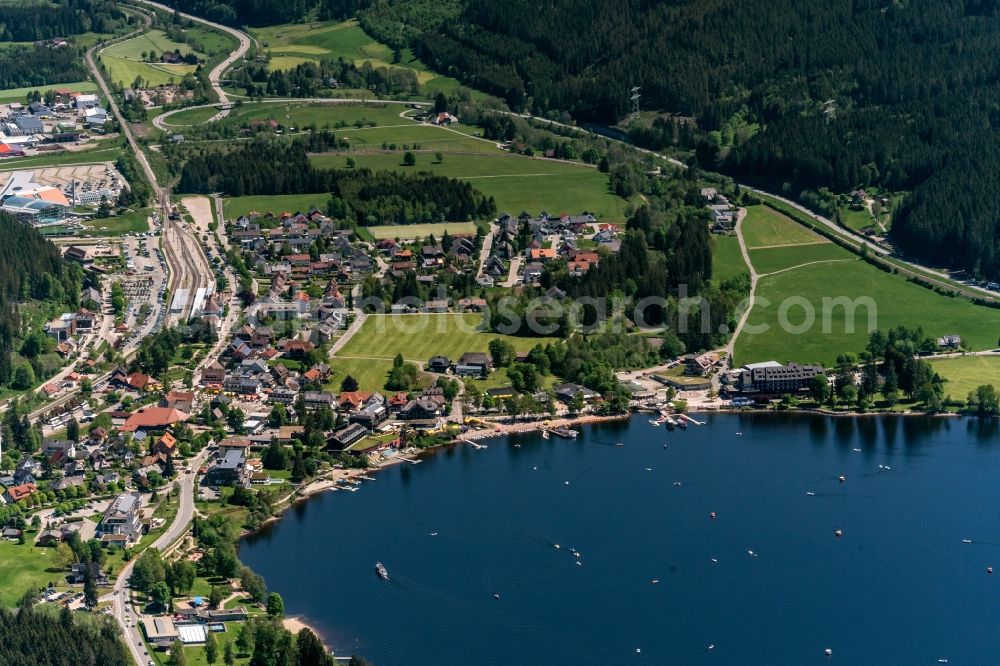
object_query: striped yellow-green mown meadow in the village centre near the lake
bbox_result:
[338,314,554,362]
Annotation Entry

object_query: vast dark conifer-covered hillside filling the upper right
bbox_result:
[361,0,1000,276]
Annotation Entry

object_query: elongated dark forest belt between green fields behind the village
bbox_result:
[177,132,496,225]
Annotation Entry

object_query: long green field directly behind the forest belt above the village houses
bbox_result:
[312,151,628,222]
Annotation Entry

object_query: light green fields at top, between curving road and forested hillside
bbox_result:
[251,20,468,97]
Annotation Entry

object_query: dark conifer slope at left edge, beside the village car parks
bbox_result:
[0,213,83,388]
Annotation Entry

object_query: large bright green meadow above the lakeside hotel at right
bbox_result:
[735,240,1000,365]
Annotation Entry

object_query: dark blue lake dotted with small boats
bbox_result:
[240,415,1000,666]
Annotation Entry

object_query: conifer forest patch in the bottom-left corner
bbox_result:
[0,603,130,666]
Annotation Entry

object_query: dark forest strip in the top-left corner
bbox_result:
[0,0,126,42]
